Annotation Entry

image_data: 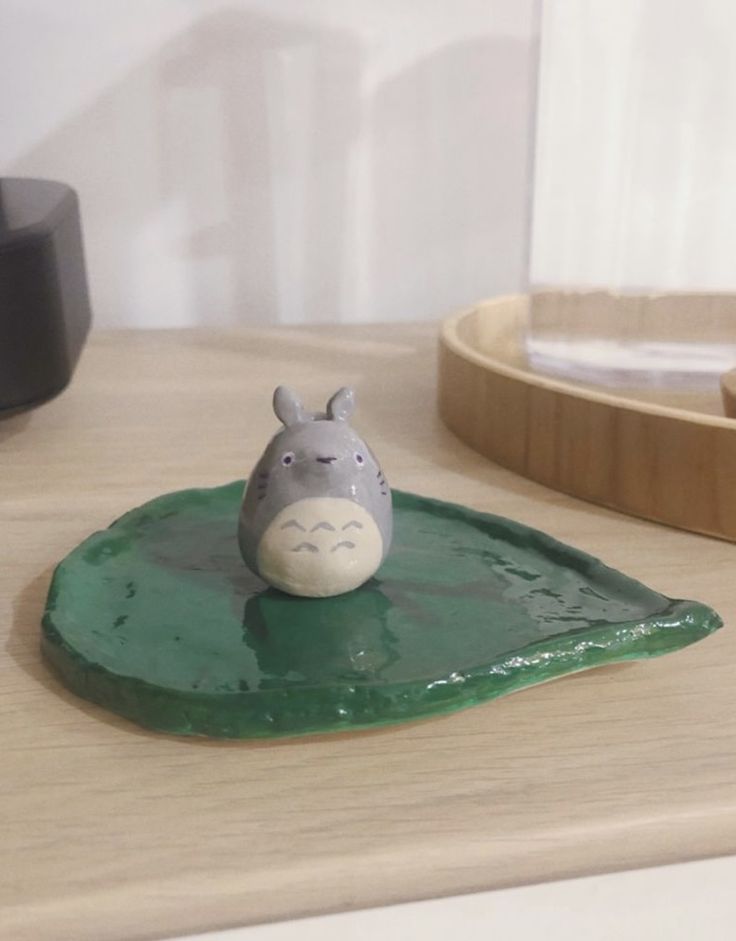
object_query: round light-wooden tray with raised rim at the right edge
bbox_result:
[439,293,736,541]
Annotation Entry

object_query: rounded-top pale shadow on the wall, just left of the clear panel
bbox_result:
[371,37,534,319]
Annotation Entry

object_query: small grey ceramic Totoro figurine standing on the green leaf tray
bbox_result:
[238,386,391,597]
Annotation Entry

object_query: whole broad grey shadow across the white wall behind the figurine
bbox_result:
[7,10,533,326]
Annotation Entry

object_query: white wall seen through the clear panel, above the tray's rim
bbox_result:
[531,0,736,291]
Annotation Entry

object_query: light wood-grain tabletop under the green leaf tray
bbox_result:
[0,325,736,941]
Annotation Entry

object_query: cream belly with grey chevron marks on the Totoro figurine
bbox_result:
[257,497,383,598]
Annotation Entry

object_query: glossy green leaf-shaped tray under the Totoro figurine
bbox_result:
[42,481,721,738]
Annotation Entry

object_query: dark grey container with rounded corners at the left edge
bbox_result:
[0,179,91,418]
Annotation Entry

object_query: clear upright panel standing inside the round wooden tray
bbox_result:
[527,0,736,398]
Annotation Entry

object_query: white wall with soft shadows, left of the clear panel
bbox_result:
[0,0,536,326]
